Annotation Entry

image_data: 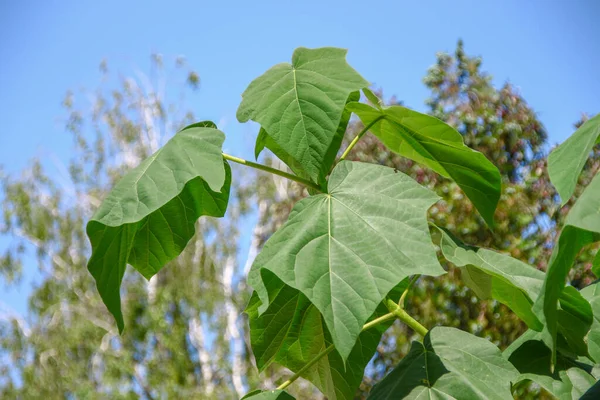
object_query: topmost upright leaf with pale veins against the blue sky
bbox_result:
[237,47,369,182]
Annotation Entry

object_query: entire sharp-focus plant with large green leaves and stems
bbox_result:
[87,48,600,400]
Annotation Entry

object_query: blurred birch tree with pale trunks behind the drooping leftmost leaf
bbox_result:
[0,55,256,400]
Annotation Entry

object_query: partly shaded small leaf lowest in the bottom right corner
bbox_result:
[503,330,595,400]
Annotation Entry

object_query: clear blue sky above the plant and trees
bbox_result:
[0,0,600,312]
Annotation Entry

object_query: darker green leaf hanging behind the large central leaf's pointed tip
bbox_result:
[246,271,408,400]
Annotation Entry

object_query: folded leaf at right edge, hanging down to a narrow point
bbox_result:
[533,175,600,366]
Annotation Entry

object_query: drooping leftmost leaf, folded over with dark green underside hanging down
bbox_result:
[86,126,231,331]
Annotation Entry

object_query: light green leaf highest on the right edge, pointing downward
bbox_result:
[548,114,600,206]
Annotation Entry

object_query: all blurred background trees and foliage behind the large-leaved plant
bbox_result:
[0,42,598,399]
